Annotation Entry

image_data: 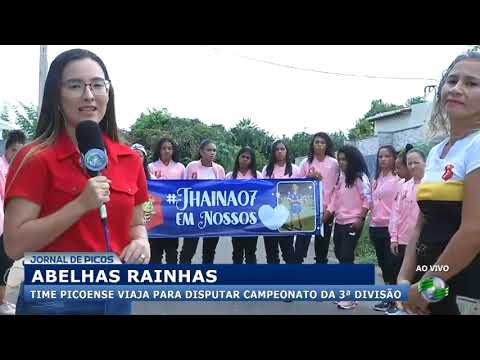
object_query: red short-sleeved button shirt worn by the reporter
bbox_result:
[5,132,148,255]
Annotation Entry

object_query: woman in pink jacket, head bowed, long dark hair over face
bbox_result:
[325,145,371,309]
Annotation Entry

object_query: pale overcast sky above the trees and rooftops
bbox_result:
[0,45,469,136]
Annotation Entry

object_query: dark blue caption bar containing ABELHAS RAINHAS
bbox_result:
[24,263,375,286]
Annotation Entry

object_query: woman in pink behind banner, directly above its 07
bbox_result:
[226,146,262,264]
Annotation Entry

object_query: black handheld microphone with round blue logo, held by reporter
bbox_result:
[75,120,110,252]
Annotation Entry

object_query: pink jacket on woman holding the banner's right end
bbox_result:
[300,156,340,209]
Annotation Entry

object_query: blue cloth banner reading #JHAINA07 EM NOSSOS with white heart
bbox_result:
[145,179,323,238]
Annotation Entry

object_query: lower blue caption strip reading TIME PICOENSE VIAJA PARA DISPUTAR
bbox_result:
[24,285,409,303]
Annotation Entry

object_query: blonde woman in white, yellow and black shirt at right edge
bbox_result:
[398,53,480,314]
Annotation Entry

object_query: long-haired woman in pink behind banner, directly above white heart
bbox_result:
[262,140,301,264]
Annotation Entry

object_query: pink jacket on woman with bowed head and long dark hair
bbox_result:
[328,173,371,225]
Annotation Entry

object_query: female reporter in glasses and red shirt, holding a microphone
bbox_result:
[4,49,150,314]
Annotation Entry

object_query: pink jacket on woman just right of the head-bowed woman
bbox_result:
[370,173,400,227]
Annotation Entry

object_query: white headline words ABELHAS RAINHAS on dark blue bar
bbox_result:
[31,269,217,284]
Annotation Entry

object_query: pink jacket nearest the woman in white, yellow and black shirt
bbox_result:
[388,178,420,245]
